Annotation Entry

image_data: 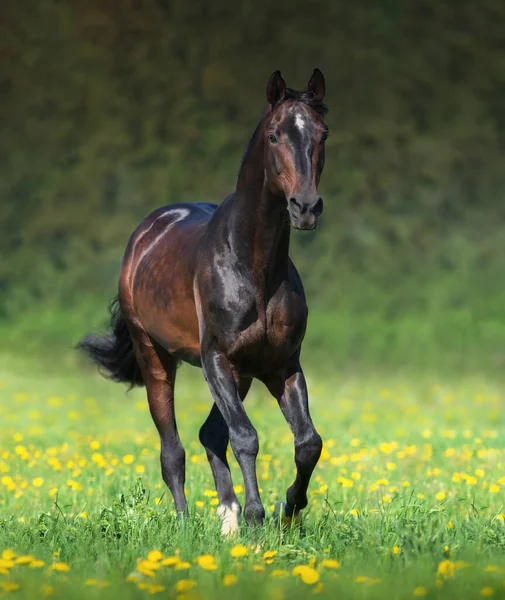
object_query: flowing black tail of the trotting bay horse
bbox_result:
[77,297,144,388]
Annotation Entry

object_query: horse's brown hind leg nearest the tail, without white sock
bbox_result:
[137,334,187,514]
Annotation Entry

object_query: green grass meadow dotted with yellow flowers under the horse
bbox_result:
[0,356,505,600]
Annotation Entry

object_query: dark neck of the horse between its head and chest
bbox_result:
[230,123,290,286]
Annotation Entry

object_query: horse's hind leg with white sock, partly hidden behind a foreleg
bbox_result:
[200,379,252,535]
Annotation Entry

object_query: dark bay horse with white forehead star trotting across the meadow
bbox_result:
[79,69,328,533]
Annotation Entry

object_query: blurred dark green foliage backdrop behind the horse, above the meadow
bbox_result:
[0,0,505,374]
